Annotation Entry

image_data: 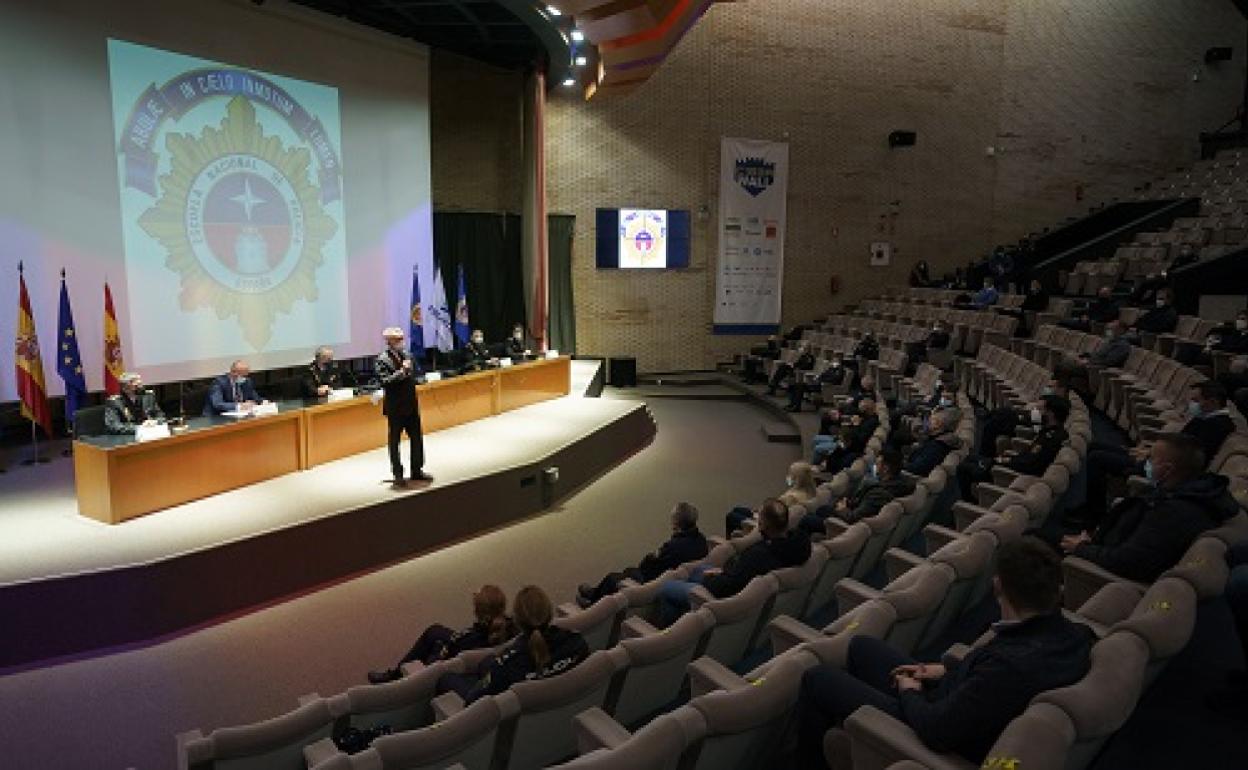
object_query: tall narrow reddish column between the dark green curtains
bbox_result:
[522,70,550,351]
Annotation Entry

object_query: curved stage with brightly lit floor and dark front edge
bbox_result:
[0,362,655,670]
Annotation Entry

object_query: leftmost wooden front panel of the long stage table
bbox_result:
[75,411,302,524]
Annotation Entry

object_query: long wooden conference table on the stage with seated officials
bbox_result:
[74,356,572,524]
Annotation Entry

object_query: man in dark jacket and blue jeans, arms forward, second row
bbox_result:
[659,498,810,628]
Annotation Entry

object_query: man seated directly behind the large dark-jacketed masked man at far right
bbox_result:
[1066,382,1236,529]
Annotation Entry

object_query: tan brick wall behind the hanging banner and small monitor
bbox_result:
[432,0,1246,372]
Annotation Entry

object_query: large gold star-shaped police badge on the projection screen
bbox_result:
[139,96,338,351]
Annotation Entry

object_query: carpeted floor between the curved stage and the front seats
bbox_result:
[0,392,799,770]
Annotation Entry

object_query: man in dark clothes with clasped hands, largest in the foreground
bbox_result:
[795,537,1096,768]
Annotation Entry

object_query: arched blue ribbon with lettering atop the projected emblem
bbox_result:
[121,67,342,203]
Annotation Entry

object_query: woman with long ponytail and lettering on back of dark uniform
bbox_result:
[437,585,589,704]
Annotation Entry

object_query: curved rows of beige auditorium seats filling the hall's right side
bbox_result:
[178,238,1248,770]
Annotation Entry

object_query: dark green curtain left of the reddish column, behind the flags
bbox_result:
[431,211,524,342]
